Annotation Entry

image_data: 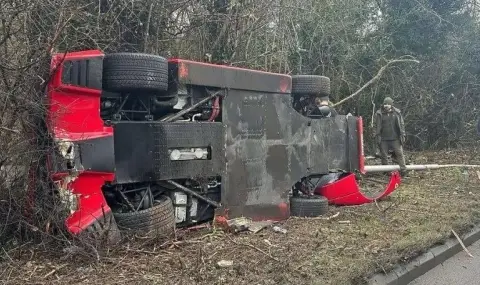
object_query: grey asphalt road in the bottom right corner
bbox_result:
[409,242,480,285]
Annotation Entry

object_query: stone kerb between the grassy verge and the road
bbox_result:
[368,225,480,285]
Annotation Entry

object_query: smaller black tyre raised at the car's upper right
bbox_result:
[292,75,330,96]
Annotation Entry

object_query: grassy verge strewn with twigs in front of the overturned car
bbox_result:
[0,150,480,284]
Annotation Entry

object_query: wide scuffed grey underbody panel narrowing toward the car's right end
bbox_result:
[220,90,358,219]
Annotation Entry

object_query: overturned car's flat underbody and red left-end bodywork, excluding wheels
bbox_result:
[41,50,364,234]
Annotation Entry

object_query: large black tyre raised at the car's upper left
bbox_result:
[102,53,168,92]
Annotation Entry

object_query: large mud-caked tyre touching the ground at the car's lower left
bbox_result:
[114,196,175,236]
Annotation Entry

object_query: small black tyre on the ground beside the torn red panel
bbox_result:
[290,195,328,217]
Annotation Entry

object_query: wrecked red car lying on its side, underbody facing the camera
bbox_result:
[39,50,382,240]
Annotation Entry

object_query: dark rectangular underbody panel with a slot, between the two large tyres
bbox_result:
[114,122,225,183]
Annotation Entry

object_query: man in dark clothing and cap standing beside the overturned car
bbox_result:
[375,97,407,176]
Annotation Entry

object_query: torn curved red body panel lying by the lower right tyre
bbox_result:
[315,172,401,206]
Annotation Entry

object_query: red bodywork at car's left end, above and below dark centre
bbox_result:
[47,50,114,234]
